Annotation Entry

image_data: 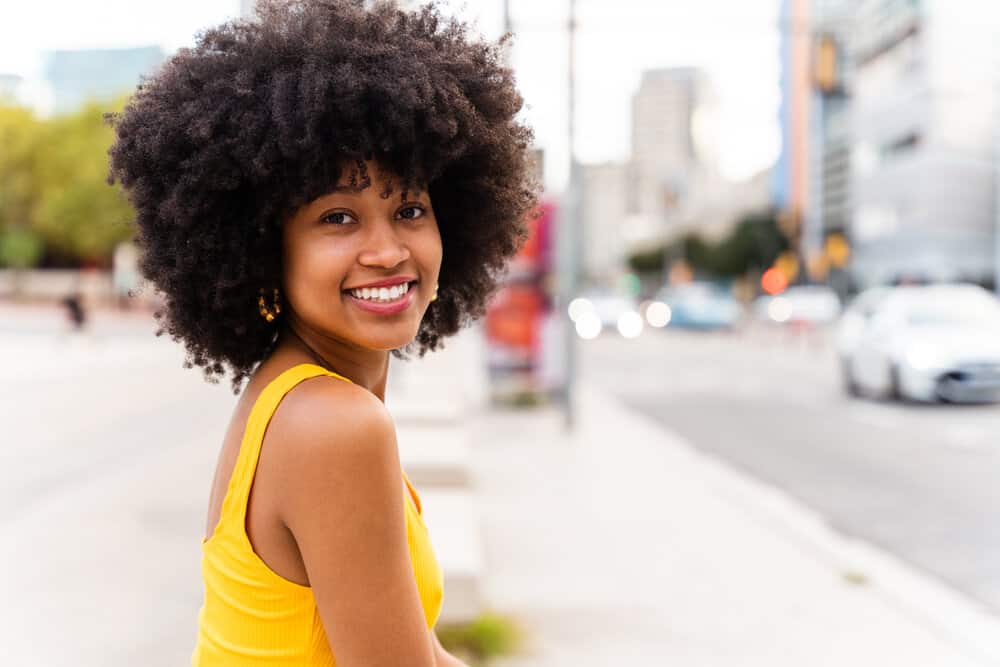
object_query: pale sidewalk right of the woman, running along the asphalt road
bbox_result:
[464,385,1000,667]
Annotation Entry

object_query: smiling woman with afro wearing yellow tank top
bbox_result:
[109,0,537,667]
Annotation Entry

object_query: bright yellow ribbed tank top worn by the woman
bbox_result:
[191,364,444,667]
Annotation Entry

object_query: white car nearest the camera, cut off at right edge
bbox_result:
[836,284,1000,403]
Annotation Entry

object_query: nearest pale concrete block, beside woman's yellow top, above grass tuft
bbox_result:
[417,487,486,623]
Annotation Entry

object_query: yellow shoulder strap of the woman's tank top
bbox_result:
[219,363,351,532]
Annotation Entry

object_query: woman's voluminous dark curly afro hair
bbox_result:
[105,0,540,394]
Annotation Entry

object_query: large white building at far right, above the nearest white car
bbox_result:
[849,0,997,287]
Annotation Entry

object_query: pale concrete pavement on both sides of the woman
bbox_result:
[0,310,1000,667]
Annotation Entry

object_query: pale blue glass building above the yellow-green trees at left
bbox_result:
[44,46,166,114]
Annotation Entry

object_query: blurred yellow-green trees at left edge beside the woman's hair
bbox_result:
[0,98,133,266]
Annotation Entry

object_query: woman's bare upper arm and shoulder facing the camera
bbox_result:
[271,378,442,667]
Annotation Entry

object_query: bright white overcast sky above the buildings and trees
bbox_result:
[0,0,780,191]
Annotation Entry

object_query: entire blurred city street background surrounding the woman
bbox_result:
[0,0,1000,667]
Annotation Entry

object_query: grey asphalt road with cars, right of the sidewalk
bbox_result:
[579,329,1000,611]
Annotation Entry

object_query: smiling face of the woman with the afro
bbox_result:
[282,162,441,350]
